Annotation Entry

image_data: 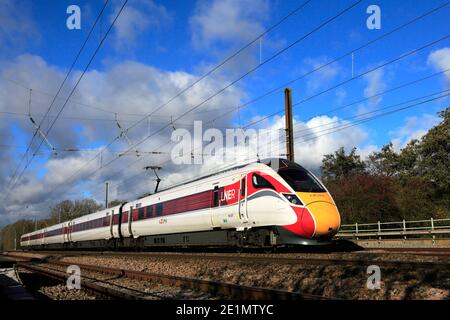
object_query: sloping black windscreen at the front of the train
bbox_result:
[278,166,326,192]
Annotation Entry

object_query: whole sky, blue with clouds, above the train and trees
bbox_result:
[0,0,450,225]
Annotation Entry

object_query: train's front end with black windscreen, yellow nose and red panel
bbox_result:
[270,159,341,244]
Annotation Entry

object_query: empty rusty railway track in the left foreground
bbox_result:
[17,261,329,300]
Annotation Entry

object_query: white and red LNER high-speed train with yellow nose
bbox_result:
[20,158,341,249]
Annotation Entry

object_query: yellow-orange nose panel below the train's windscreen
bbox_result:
[307,201,341,237]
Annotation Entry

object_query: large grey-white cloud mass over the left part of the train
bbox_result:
[0,55,244,222]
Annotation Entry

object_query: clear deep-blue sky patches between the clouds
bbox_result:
[8,1,449,145]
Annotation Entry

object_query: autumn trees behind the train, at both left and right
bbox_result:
[0,107,450,250]
